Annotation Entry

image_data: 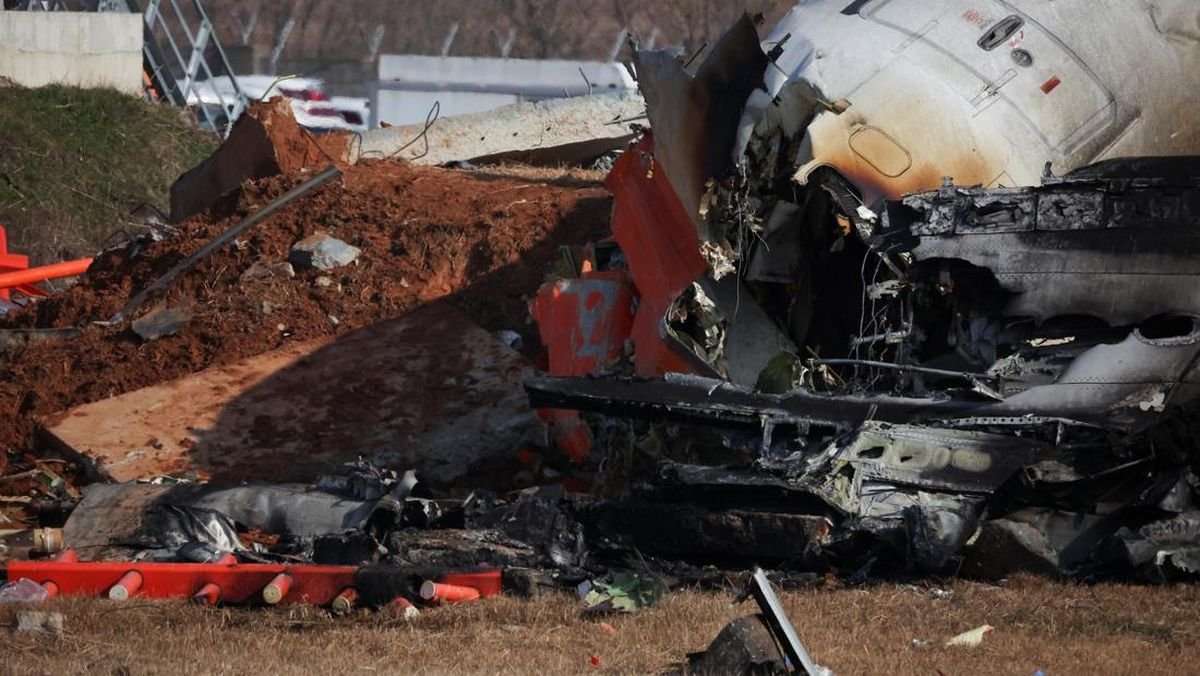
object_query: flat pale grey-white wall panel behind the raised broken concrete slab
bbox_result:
[371,54,637,127]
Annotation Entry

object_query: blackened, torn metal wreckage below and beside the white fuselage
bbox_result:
[527,17,1200,580]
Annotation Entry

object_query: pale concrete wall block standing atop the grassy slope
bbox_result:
[0,12,142,94]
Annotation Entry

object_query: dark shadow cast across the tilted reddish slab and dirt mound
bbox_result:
[187,195,611,490]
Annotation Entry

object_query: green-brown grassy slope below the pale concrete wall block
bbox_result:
[0,86,217,263]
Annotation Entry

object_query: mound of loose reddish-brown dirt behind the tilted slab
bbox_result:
[0,153,611,470]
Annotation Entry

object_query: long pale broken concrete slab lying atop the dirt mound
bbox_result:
[349,92,646,164]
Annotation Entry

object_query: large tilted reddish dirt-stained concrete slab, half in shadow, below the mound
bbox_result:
[43,304,539,483]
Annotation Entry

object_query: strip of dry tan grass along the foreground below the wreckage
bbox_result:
[0,578,1200,676]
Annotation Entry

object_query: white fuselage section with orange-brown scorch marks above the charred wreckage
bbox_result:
[734,0,1200,202]
